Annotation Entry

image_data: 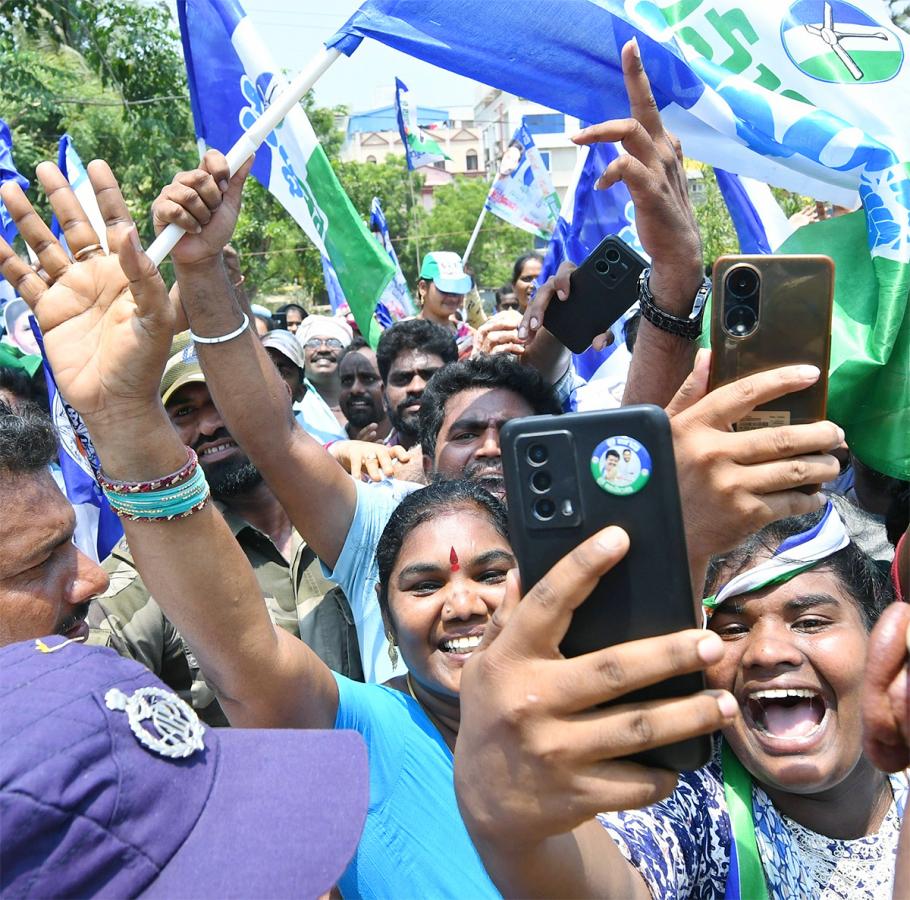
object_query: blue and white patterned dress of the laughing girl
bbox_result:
[598,758,907,900]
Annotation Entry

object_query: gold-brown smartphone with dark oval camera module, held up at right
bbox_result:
[710,254,834,431]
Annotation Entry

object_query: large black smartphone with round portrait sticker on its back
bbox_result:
[501,405,711,771]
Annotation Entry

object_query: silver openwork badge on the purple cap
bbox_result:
[104,687,205,759]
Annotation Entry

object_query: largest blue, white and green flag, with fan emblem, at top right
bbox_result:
[327,0,910,478]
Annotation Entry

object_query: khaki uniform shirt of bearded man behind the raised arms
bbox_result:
[87,504,363,725]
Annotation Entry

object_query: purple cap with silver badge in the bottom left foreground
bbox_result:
[0,637,369,898]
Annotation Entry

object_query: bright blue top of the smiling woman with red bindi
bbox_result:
[333,673,500,900]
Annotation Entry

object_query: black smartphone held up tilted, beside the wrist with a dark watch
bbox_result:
[543,234,648,353]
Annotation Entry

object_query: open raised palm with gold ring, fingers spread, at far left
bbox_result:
[0,160,175,424]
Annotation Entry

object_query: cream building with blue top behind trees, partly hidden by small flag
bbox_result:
[336,104,486,209]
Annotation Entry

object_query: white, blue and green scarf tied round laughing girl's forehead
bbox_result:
[702,500,850,616]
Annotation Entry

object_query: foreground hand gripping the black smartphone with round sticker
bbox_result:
[455,527,738,896]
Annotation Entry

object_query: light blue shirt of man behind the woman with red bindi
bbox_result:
[322,481,421,684]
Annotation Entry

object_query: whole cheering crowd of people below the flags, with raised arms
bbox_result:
[0,44,910,900]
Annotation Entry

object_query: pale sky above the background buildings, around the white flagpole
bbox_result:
[161,0,482,112]
